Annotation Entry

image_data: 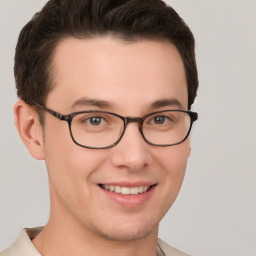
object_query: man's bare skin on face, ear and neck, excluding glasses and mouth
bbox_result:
[14,36,190,256]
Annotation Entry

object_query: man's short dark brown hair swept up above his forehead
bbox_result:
[14,0,198,109]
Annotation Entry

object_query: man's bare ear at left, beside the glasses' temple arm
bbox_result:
[14,100,44,160]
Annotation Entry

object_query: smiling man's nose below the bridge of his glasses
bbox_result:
[112,123,151,171]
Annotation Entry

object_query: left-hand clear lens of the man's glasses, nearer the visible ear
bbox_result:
[71,112,124,148]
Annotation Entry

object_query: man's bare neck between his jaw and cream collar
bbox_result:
[33,196,158,256]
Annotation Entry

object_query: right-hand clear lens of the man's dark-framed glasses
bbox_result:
[142,111,191,145]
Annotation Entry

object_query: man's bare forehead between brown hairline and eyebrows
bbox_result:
[47,36,187,112]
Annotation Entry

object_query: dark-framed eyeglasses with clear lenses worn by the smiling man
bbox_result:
[33,102,198,149]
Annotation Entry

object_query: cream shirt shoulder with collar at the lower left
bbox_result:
[0,227,42,256]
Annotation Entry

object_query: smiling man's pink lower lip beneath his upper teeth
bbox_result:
[100,186,156,208]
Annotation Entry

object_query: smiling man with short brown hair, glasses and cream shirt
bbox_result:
[1,0,198,256]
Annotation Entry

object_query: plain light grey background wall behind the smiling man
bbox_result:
[0,0,256,256]
